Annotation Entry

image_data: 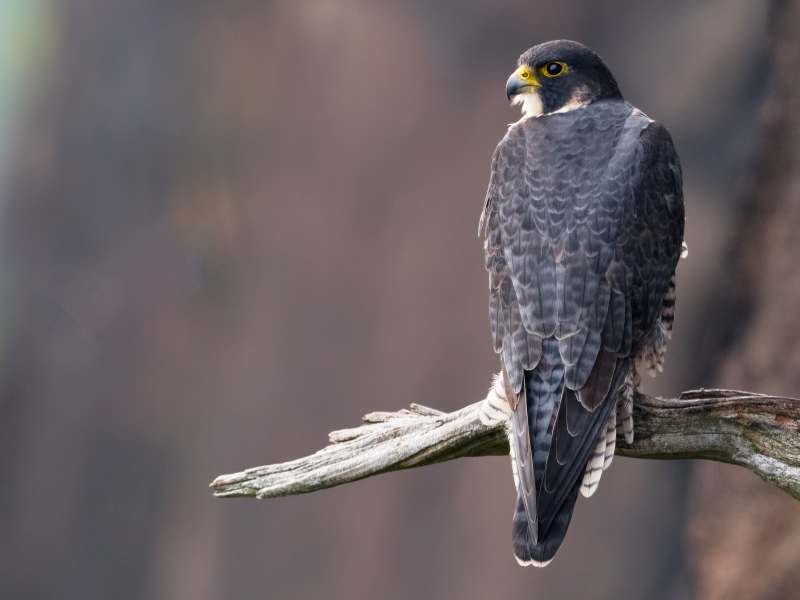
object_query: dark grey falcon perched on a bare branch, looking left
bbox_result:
[479,40,686,567]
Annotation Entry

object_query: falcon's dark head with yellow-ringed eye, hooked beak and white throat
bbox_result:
[506,40,622,117]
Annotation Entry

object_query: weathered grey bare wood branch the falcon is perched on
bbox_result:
[211,390,800,500]
